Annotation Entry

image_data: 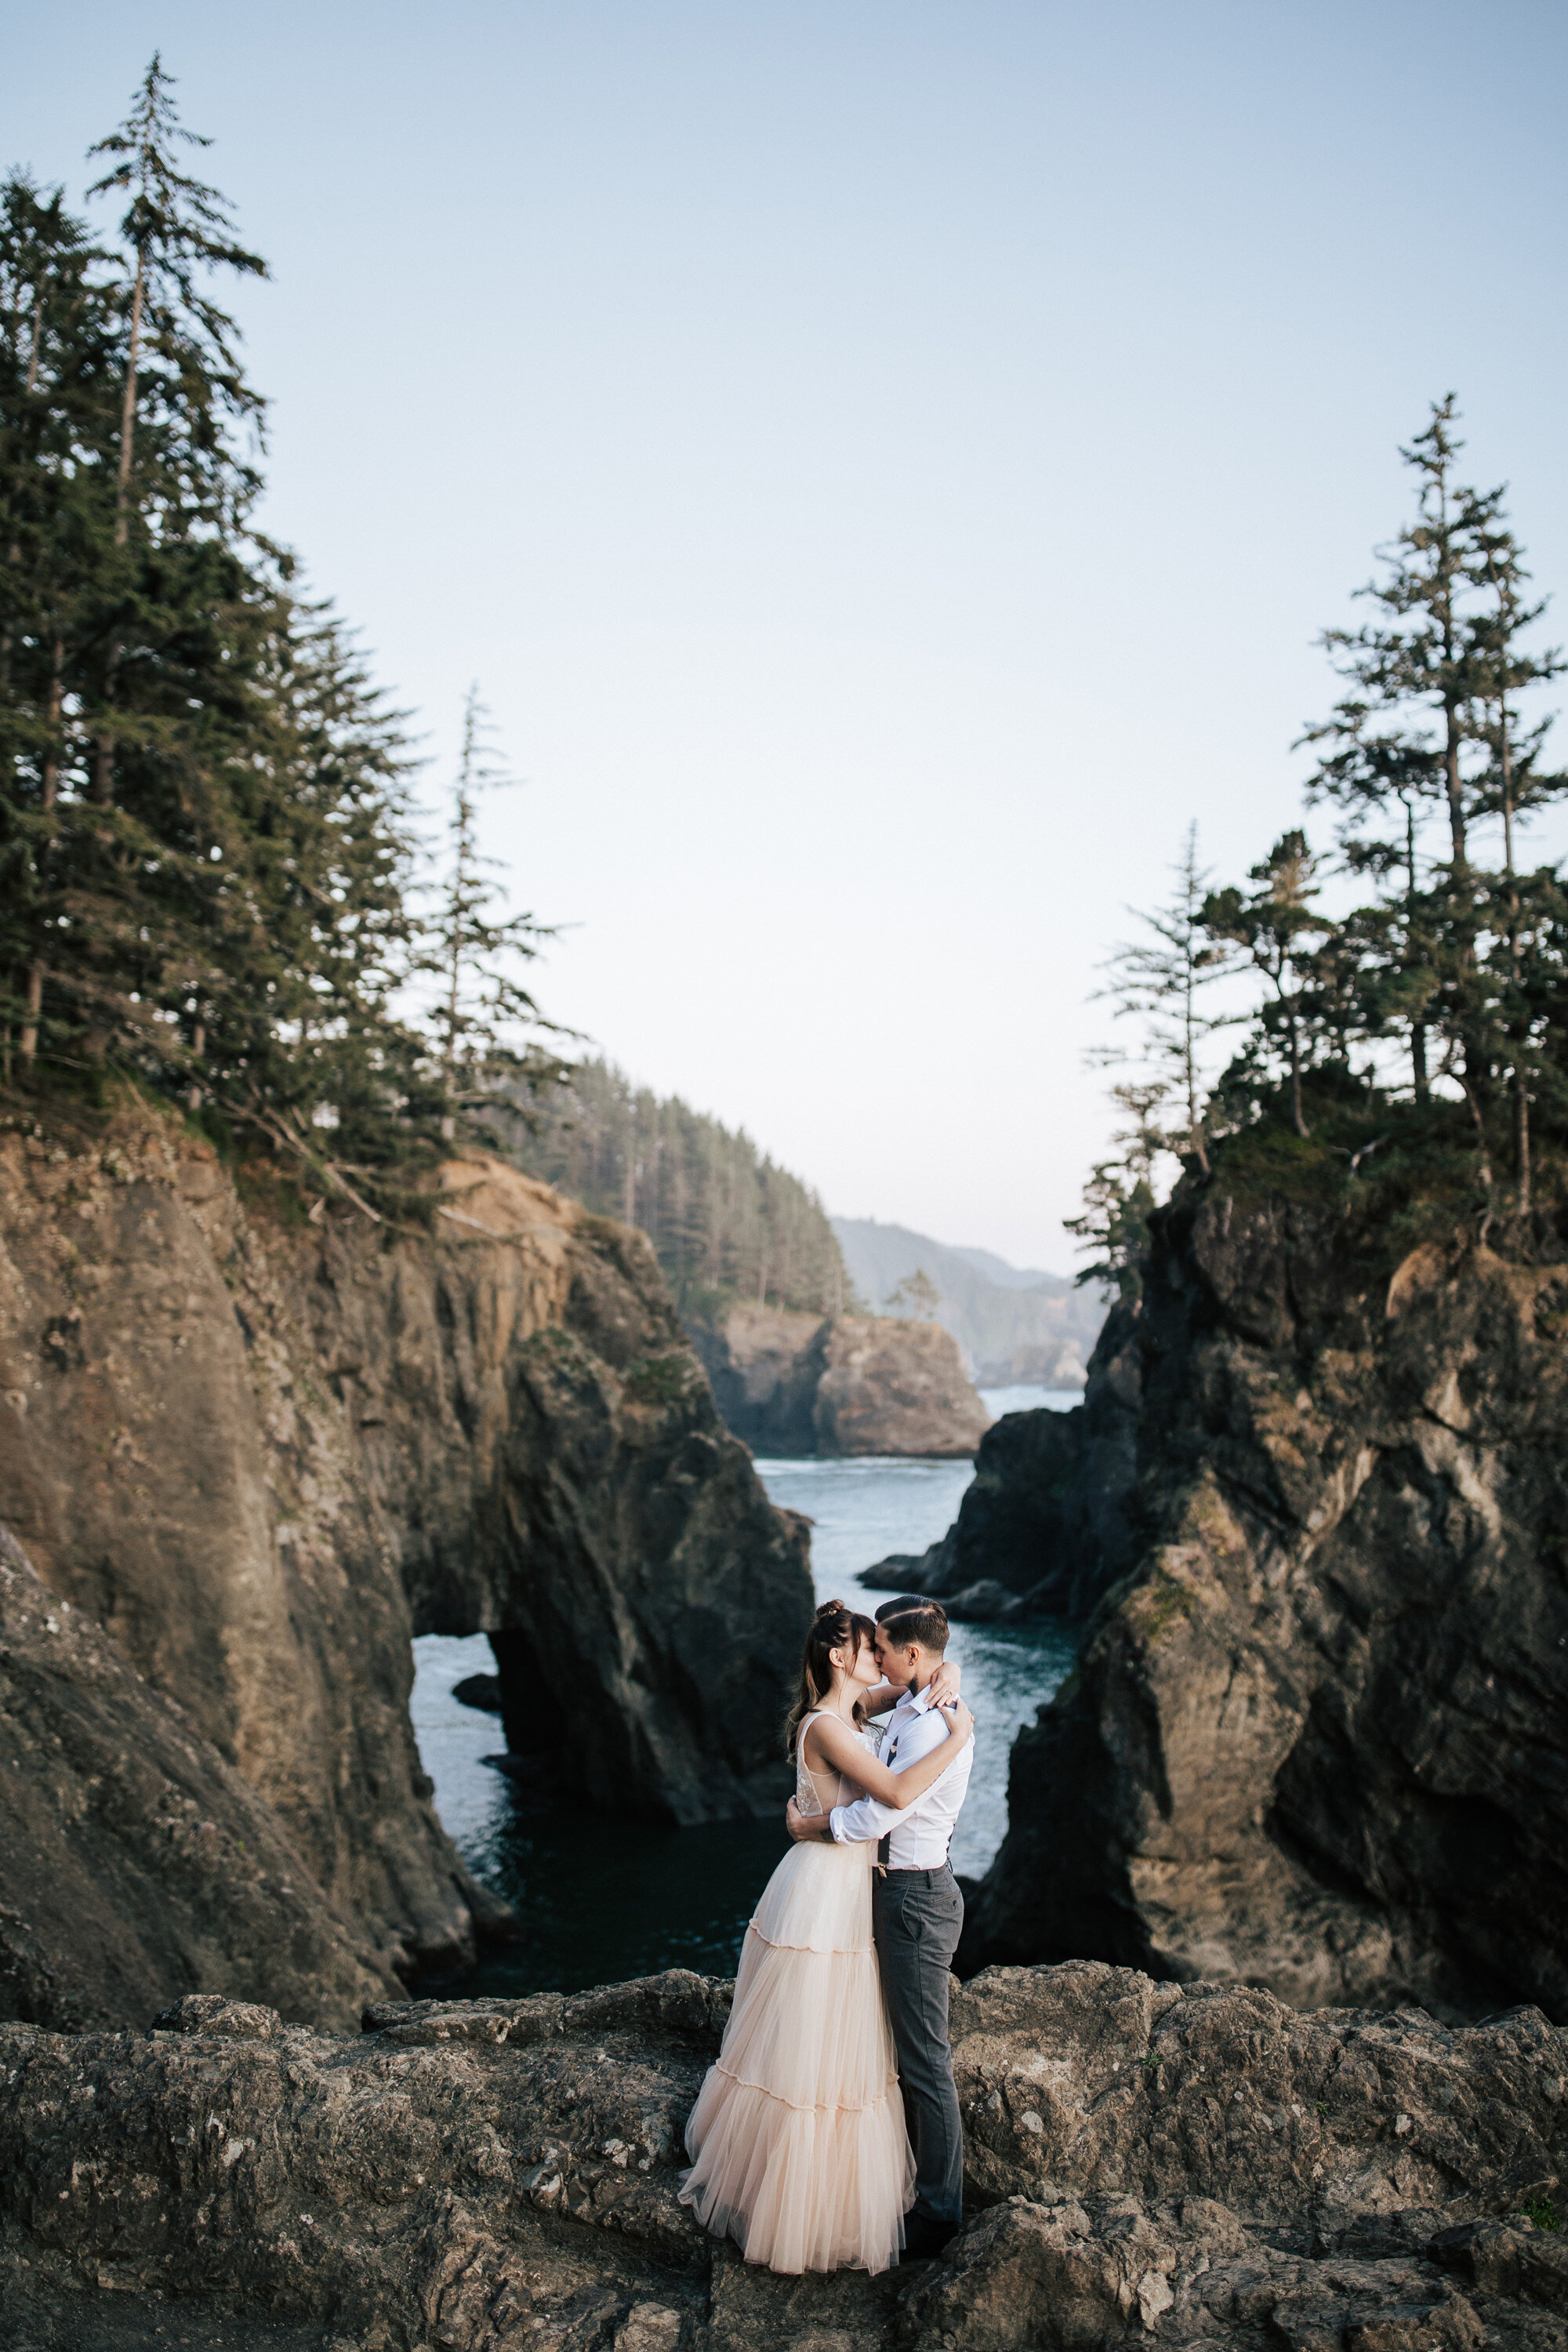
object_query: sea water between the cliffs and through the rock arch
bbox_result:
[414,1388,1079,1994]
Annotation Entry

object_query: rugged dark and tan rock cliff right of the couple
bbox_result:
[966,1181,1568,2018]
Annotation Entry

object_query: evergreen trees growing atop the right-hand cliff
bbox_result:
[1072,397,1568,1296]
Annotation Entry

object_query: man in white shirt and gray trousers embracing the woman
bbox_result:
[785,1599,975,2263]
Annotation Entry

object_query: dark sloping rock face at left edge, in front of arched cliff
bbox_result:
[0,1529,400,2032]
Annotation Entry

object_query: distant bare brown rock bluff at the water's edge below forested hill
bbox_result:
[687,1303,987,1458]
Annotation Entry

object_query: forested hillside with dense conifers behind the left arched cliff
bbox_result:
[508,1061,855,1317]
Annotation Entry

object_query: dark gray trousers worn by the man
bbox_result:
[872,1863,964,2230]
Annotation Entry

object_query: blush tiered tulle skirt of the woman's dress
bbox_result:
[682,1842,914,2272]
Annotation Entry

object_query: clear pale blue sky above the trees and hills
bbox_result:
[0,0,1568,1268]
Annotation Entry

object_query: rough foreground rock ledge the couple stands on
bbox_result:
[0,1962,1568,2352]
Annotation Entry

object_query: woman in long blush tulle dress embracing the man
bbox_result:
[682,1602,973,2272]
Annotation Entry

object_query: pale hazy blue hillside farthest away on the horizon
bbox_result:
[832,1216,1105,1388]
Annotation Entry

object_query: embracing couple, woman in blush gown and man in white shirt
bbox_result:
[680,1597,973,2272]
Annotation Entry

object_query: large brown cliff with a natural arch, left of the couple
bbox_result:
[0,1103,811,2004]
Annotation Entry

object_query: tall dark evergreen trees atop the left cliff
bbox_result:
[0,59,557,1192]
